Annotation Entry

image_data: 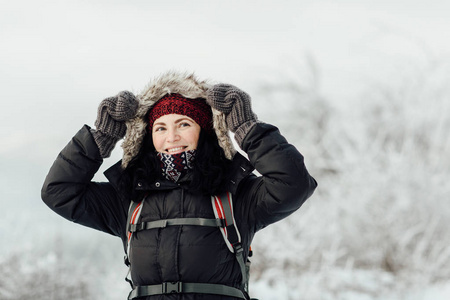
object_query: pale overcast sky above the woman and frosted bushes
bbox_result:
[0,0,450,202]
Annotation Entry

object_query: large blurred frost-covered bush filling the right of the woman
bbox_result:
[253,56,450,299]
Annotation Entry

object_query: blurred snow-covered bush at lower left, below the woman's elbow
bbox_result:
[0,226,130,300]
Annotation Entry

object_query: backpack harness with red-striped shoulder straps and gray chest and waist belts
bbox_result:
[124,192,257,300]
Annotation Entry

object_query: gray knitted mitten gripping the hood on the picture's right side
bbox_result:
[206,83,257,146]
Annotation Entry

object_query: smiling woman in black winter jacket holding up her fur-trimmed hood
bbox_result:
[42,72,317,299]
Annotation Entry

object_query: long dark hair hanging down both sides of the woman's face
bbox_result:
[119,129,230,201]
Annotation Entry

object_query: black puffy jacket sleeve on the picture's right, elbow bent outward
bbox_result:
[239,123,317,232]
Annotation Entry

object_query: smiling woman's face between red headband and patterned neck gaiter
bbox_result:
[152,114,200,154]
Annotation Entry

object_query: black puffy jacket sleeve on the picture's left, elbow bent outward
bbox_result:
[41,125,127,236]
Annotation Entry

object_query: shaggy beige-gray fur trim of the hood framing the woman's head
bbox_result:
[122,71,236,169]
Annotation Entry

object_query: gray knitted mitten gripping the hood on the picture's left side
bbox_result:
[93,91,139,158]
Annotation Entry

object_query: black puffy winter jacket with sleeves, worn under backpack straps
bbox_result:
[42,123,317,300]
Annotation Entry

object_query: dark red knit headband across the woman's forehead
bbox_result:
[148,94,213,132]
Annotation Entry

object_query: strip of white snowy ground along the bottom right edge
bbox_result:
[250,269,450,300]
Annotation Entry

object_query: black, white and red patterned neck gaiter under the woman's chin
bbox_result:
[158,150,197,182]
